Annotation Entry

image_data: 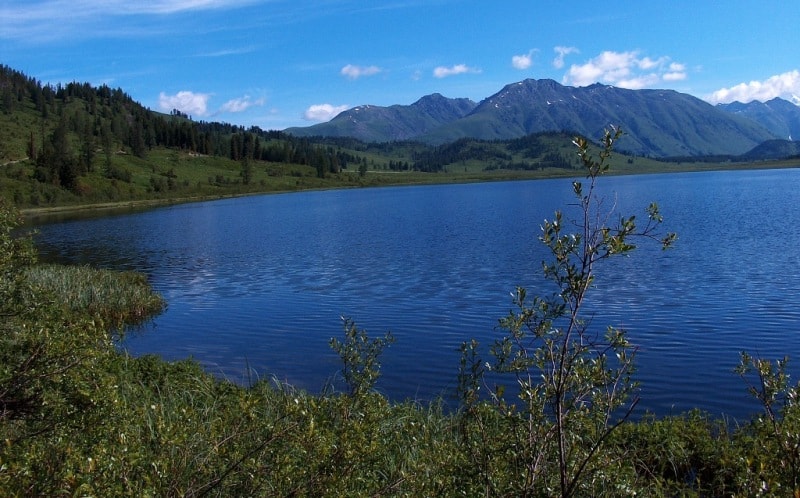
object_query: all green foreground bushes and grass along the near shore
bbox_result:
[0,128,800,496]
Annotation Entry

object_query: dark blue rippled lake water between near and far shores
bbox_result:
[29,170,800,417]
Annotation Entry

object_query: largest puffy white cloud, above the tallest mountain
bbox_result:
[564,50,686,90]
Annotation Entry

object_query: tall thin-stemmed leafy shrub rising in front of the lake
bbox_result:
[461,129,675,496]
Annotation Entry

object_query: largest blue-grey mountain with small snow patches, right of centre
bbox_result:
[424,80,775,157]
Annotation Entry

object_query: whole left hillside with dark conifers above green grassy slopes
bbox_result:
[0,66,406,207]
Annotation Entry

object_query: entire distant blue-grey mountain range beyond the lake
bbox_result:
[285,79,800,157]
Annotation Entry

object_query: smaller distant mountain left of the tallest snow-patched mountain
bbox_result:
[285,93,476,142]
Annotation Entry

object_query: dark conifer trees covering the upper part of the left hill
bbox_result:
[0,65,366,188]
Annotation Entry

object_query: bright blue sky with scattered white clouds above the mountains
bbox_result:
[0,0,800,129]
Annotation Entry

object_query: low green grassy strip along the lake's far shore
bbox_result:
[9,141,800,223]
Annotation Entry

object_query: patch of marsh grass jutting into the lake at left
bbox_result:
[27,264,166,330]
